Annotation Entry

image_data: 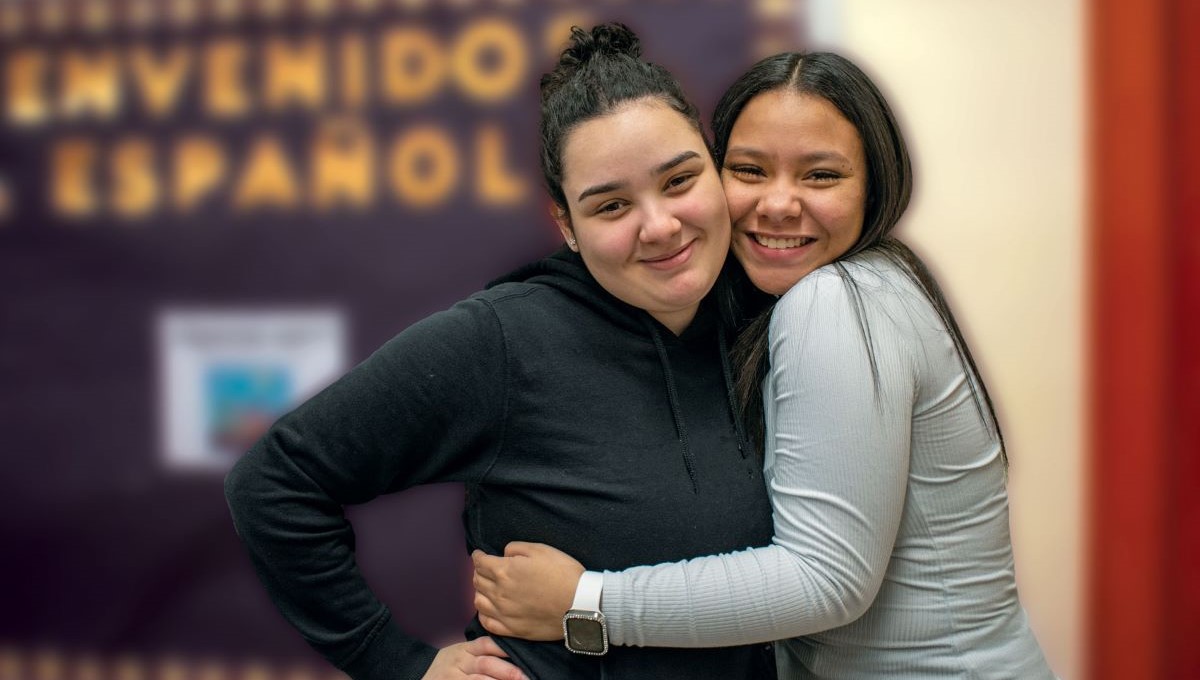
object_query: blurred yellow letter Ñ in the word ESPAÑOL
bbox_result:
[312,119,376,210]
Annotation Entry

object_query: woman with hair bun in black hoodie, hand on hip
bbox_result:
[226,25,773,680]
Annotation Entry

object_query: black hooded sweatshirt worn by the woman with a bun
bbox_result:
[226,248,772,680]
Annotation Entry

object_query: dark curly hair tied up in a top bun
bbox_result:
[540,23,707,210]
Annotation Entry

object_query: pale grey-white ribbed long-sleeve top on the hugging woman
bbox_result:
[602,252,1054,680]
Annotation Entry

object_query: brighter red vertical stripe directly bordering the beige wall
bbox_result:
[1088,0,1169,680]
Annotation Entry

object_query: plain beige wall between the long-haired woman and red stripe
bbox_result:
[808,0,1086,678]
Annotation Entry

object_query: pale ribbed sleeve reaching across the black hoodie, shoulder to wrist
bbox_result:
[604,260,914,646]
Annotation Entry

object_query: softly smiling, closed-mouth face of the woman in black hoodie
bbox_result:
[556,98,730,333]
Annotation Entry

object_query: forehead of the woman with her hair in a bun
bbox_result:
[563,98,708,185]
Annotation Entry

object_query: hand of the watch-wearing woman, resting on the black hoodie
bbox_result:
[470,541,584,640]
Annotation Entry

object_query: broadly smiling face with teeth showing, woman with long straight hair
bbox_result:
[721,90,866,295]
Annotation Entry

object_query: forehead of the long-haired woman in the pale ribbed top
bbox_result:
[730,90,862,156]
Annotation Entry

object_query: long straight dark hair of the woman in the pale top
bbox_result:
[713,52,1008,464]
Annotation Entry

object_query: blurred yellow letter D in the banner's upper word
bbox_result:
[380,28,446,104]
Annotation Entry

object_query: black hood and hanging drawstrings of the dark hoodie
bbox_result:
[487,246,749,493]
